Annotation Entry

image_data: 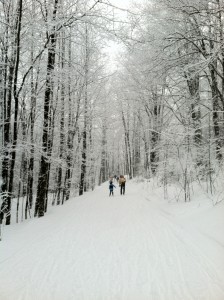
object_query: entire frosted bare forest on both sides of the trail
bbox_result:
[0,0,224,225]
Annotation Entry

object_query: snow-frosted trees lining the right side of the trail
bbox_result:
[114,0,224,201]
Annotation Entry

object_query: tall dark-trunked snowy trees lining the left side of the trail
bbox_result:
[0,0,121,225]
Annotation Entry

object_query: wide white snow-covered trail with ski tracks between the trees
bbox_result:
[0,183,224,300]
